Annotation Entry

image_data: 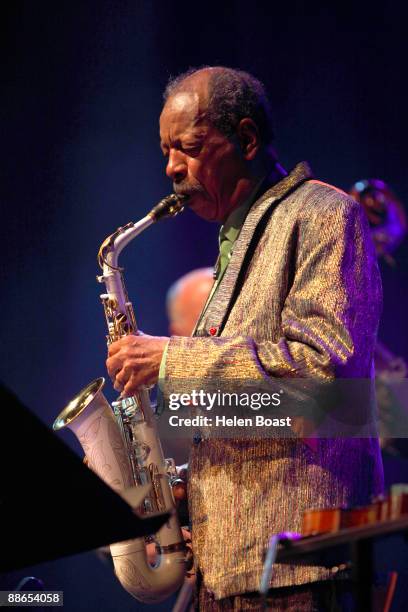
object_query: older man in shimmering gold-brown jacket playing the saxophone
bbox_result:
[107,67,382,612]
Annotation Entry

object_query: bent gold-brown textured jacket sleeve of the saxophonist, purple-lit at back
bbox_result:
[165,194,381,390]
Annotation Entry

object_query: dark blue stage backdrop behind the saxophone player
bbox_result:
[0,0,408,610]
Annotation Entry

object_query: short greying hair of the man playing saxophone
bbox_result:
[163,66,274,145]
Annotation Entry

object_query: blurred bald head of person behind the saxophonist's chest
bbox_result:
[166,268,214,336]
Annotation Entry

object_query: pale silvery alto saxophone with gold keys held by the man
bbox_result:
[53,194,186,603]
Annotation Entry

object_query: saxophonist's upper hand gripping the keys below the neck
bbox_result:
[106,333,169,397]
